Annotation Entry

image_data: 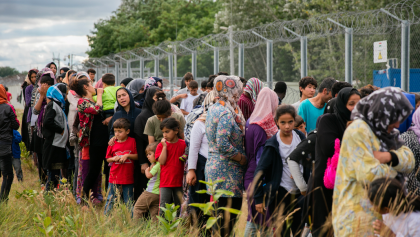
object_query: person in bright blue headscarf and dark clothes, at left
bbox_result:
[42,83,69,190]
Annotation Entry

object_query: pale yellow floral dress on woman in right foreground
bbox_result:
[332,119,415,237]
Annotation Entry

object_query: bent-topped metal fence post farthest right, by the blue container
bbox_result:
[380,8,410,92]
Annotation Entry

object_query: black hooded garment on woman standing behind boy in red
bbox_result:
[109,87,141,139]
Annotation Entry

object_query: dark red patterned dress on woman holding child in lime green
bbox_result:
[77,98,102,147]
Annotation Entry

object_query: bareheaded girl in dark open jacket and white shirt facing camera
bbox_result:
[251,105,305,236]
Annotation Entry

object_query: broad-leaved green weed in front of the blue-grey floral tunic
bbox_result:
[190,179,241,229]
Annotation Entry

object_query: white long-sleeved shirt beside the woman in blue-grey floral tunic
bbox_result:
[188,119,209,170]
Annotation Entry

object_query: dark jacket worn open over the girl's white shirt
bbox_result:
[253,129,306,206]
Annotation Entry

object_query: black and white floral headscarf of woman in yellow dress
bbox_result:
[351,87,413,151]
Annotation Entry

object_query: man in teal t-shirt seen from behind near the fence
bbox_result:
[298,78,336,134]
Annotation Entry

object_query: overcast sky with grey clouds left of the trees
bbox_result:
[0,0,120,71]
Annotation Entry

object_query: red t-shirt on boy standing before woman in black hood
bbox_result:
[106,137,137,184]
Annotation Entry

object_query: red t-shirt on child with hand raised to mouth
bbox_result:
[155,139,187,188]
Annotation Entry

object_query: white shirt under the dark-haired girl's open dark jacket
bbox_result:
[276,131,303,194]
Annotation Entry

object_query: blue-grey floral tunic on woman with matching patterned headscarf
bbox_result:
[204,103,245,198]
